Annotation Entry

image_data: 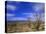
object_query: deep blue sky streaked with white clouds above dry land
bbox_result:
[7,1,44,21]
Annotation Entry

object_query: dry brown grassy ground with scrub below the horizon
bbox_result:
[7,22,45,32]
